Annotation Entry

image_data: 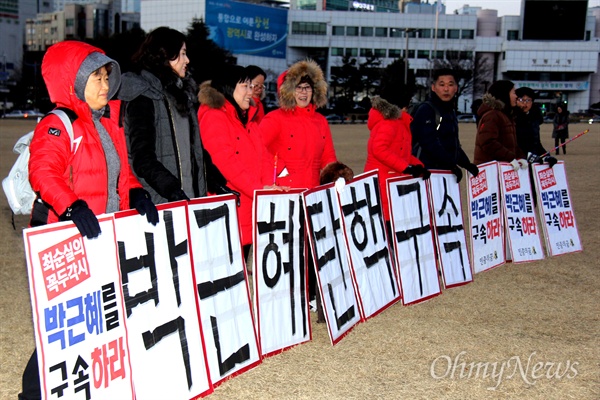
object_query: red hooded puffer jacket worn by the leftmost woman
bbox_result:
[29,41,141,223]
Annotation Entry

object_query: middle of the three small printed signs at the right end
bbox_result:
[500,162,544,263]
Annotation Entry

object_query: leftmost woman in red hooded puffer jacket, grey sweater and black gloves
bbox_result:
[19,41,158,399]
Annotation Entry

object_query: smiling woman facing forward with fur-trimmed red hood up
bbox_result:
[260,60,337,189]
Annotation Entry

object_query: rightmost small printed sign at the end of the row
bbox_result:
[534,161,583,256]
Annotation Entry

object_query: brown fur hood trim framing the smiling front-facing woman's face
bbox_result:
[277,60,327,110]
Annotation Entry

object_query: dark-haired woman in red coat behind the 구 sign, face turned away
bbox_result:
[365,95,431,222]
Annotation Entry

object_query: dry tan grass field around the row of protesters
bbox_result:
[0,120,600,400]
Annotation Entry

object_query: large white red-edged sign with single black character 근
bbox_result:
[187,195,261,385]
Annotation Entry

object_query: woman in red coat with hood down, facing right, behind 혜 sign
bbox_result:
[198,65,277,256]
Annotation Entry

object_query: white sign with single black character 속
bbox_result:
[428,171,473,288]
